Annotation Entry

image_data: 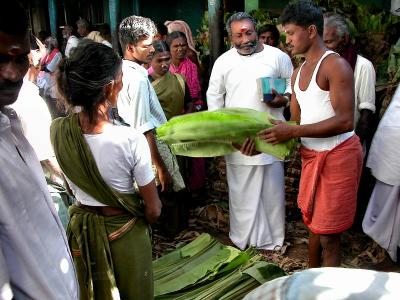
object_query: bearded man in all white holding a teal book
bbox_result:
[207,12,293,250]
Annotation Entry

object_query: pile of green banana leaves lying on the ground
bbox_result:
[153,233,286,300]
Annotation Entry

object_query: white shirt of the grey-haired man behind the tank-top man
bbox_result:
[354,55,376,126]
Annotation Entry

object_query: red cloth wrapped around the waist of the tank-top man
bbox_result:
[297,135,362,234]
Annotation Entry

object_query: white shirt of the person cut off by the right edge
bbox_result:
[367,87,400,186]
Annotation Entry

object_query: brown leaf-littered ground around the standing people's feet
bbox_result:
[153,158,400,274]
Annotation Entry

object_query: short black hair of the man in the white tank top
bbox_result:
[279,0,324,37]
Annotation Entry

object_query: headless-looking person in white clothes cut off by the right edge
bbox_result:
[362,87,400,265]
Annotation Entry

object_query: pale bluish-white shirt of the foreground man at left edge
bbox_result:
[0,108,78,300]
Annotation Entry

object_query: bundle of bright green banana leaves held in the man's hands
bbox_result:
[157,108,297,159]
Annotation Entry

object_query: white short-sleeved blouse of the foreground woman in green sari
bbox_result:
[67,124,154,206]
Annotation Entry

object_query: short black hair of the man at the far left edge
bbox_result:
[0,0,29,36]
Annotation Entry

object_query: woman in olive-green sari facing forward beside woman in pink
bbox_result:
[149,41,193,120]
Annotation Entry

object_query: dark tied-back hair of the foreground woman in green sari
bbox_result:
[57,39,121,124]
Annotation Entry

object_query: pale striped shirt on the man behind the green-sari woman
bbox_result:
[117,59,167,133]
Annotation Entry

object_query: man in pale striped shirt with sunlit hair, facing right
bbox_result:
[117,16,185,206]
